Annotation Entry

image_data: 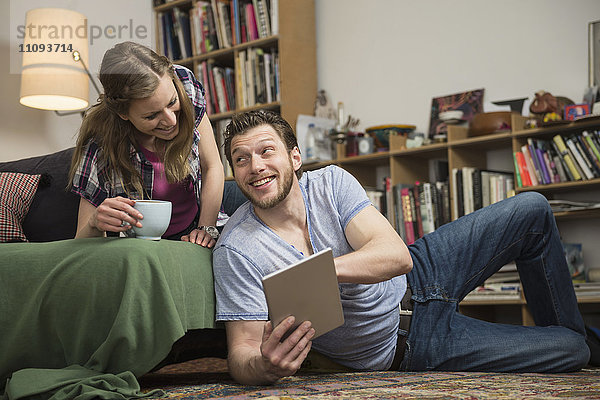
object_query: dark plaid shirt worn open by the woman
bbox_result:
[71,65,207,208]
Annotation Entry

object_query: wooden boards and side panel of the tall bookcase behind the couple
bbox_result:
[153,0,317,134]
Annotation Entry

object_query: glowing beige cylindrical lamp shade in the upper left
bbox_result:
[20,8,89,111]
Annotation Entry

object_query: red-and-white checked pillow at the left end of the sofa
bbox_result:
[0,172,40,243]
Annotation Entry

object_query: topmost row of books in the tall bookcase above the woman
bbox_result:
[155,0,279,60]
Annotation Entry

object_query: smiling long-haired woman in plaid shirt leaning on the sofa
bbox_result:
[70,42,224,247]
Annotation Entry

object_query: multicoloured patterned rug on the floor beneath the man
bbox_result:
[140,359,600,400]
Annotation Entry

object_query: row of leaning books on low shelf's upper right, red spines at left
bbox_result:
[514,131,600,187]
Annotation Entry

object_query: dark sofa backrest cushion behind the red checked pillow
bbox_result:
[0,148,79,242]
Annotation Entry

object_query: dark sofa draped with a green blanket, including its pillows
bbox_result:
[0,148,246,399]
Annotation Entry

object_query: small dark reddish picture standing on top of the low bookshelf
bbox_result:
[429,89,484,139]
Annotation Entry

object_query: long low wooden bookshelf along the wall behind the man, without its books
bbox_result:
[305,115,600,325]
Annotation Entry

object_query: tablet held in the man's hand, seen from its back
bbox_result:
[262,248,344,338]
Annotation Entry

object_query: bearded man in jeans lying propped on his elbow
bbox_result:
[213,111,590,384]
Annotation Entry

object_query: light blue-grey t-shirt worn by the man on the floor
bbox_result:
[213,166,406,370]
